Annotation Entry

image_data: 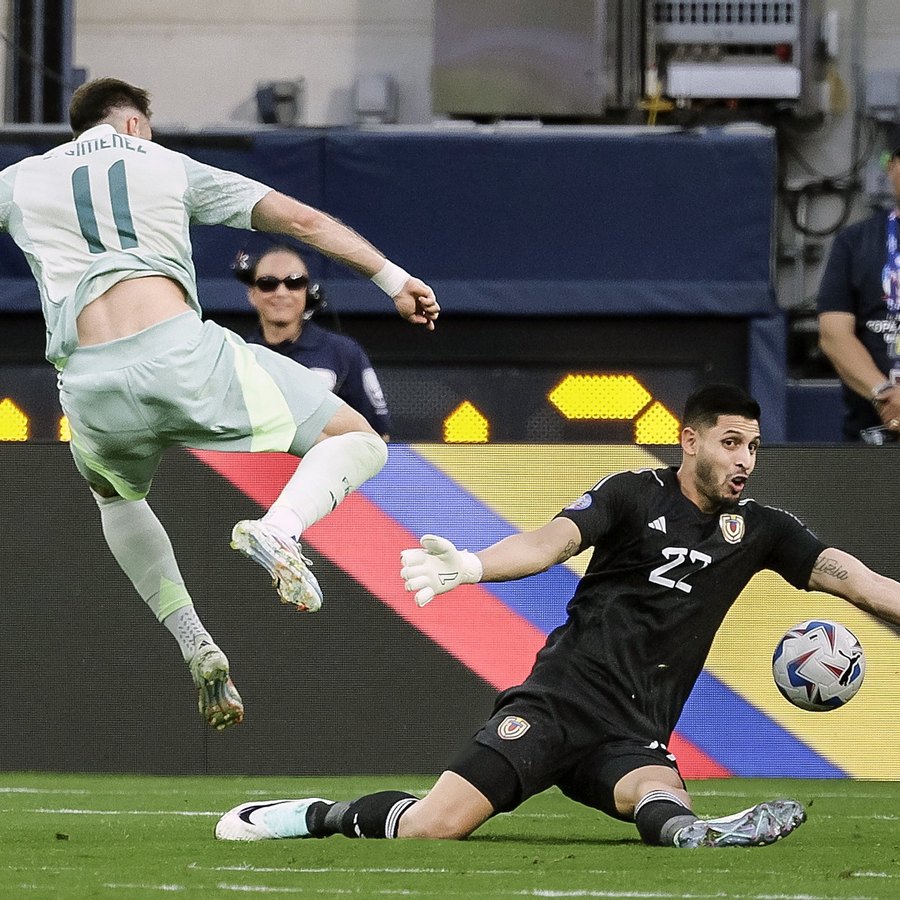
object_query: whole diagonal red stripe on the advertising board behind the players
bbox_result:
[190,450,731,778]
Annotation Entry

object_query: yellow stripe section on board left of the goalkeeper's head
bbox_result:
[410,444,663,576]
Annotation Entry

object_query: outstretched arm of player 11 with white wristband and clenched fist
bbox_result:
[251,191,441,331]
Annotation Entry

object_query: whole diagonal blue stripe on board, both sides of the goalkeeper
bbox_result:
[372,444,847,778]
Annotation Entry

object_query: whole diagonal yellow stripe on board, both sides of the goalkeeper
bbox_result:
[412,444,900,779]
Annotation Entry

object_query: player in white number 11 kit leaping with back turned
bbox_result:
[0,78,440,729]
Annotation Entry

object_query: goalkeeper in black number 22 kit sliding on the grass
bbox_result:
[216,385,900,848]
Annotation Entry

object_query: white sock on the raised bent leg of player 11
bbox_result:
[262,431,387,538]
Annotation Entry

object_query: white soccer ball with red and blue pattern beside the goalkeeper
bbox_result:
[772,619,866,712]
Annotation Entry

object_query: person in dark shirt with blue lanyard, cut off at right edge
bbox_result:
[818,147,900,441]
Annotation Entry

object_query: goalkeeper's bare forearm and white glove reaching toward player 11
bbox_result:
[400,518,581,606]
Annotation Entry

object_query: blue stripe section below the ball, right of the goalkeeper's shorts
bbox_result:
[678,669,847,778]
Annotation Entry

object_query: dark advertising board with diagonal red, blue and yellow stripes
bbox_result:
[0,444,900,779]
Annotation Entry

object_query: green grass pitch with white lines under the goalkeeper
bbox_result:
[0,773,900,900]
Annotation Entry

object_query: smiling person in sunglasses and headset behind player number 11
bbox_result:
[241,245,391,440]
